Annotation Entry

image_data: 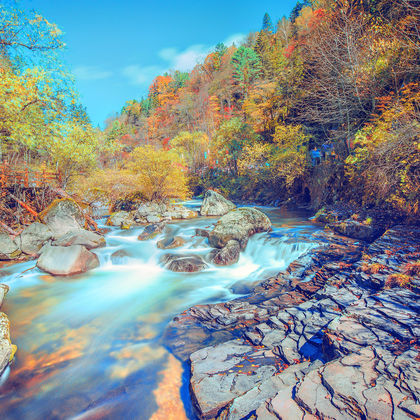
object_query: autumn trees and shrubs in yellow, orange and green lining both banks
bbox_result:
[0,0,420,230]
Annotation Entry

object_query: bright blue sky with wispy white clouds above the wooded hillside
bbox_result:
[20,0,296,125]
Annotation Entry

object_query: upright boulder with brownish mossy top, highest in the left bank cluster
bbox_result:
[40,198,85,238]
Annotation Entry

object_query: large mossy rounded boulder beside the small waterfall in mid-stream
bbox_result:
[209,207,271,249]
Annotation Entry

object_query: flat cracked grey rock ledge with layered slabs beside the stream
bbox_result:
[165,226,420,420]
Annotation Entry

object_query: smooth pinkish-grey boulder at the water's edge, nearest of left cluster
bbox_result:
[36,245,99,276]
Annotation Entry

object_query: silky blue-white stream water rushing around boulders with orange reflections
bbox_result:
[0,201,318,420]
